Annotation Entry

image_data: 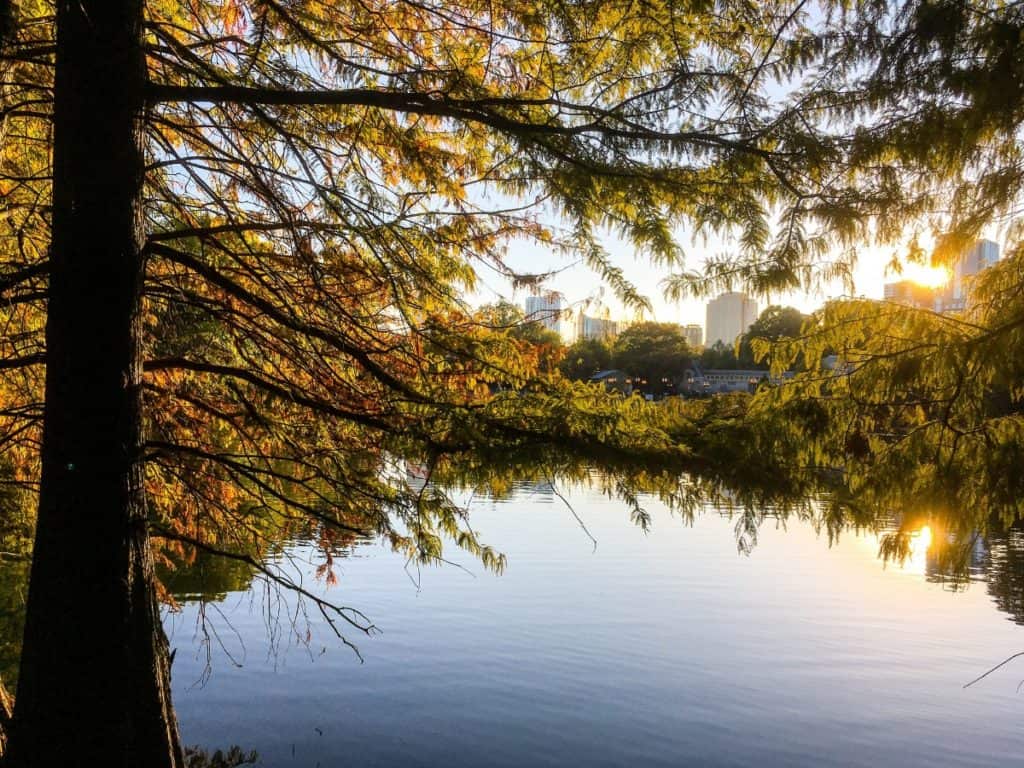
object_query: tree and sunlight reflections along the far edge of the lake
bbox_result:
[160,472,1024,638]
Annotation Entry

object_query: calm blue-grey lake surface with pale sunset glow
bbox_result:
[167,486,1024,768]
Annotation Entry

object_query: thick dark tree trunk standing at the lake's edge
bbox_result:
[7,0,183,768]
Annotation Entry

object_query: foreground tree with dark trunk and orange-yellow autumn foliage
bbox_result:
[6,0,1022,768]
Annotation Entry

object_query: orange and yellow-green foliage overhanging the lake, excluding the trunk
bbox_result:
[0,0,1024,667]
